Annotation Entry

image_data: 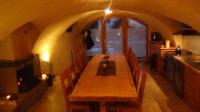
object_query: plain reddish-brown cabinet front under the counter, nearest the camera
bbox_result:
[184,66,200,111]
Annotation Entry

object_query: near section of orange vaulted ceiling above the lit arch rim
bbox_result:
[0,0,200,40]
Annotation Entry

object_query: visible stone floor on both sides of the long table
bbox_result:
[28,72,195,112]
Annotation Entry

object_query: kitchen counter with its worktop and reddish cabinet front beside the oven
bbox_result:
[167,53,200,112]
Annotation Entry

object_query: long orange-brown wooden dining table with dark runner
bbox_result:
[70,55,137,112]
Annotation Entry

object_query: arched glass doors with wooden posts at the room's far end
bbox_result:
[87,17,147,58]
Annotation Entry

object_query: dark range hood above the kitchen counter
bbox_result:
[173,23,200,35]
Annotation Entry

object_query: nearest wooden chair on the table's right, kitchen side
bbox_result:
[109,70,146,112]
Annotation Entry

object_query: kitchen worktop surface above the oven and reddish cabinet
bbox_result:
[174,54,200,74]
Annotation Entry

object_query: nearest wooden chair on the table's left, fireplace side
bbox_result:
[60,71,90,112]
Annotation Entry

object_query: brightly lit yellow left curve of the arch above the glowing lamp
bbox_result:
[33,11,102,55]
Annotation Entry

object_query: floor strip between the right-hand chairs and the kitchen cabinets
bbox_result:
[142,73,195,112]
